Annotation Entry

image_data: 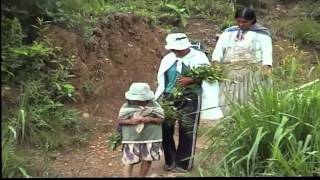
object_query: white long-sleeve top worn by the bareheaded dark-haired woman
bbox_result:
[212,31,273,66]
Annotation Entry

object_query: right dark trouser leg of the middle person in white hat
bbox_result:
[176,95,201,170]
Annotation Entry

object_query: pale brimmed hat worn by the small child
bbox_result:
[125,82,154,101]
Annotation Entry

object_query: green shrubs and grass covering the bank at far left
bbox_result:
[1,17,91,177]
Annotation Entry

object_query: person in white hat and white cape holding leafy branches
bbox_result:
[155,33,210,171]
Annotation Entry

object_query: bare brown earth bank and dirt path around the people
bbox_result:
[48,14,218,177]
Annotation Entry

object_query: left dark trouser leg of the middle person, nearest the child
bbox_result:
[162,120,176,170]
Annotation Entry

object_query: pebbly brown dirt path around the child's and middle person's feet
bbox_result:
[50,115,215,177]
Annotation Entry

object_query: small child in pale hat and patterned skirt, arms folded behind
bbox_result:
[118,83,164,176]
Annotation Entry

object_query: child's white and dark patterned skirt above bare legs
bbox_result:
[122,142,162,164]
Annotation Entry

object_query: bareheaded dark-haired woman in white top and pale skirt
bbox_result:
[212,8,273,114]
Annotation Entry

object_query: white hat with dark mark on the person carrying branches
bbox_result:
[164,33,191,50]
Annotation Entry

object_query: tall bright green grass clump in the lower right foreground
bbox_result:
[202,82,320,176]
